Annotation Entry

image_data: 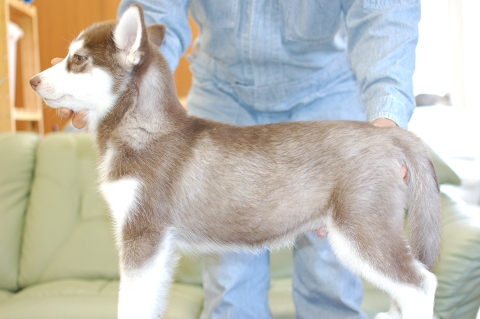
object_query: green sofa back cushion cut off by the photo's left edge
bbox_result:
[0,133,39,292]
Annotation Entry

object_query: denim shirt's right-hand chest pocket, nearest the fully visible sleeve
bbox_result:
[281,0,341,42]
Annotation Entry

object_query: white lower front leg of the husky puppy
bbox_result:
[118,230,177,319]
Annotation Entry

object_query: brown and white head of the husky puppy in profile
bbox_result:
[30,5,166,128]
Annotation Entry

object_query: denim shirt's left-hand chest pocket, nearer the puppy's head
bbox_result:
[191,0,239,28]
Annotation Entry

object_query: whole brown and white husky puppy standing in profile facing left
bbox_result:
[30,5,441,319]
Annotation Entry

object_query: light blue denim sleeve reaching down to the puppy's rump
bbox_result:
[344,0,420,128]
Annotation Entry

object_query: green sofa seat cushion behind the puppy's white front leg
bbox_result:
[0,279,203,319]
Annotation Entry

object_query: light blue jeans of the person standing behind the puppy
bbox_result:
[187,72,367,319]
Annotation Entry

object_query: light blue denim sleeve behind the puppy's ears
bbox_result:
[118,0,192,72]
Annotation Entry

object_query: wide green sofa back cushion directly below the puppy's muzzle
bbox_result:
[19,134,118,287]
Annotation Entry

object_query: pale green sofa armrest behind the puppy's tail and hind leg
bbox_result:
[434,193,480,319]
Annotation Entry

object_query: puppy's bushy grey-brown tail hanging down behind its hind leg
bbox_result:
[404,141,442,270]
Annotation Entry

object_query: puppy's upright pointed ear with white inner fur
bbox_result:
[113,4,147,66]
